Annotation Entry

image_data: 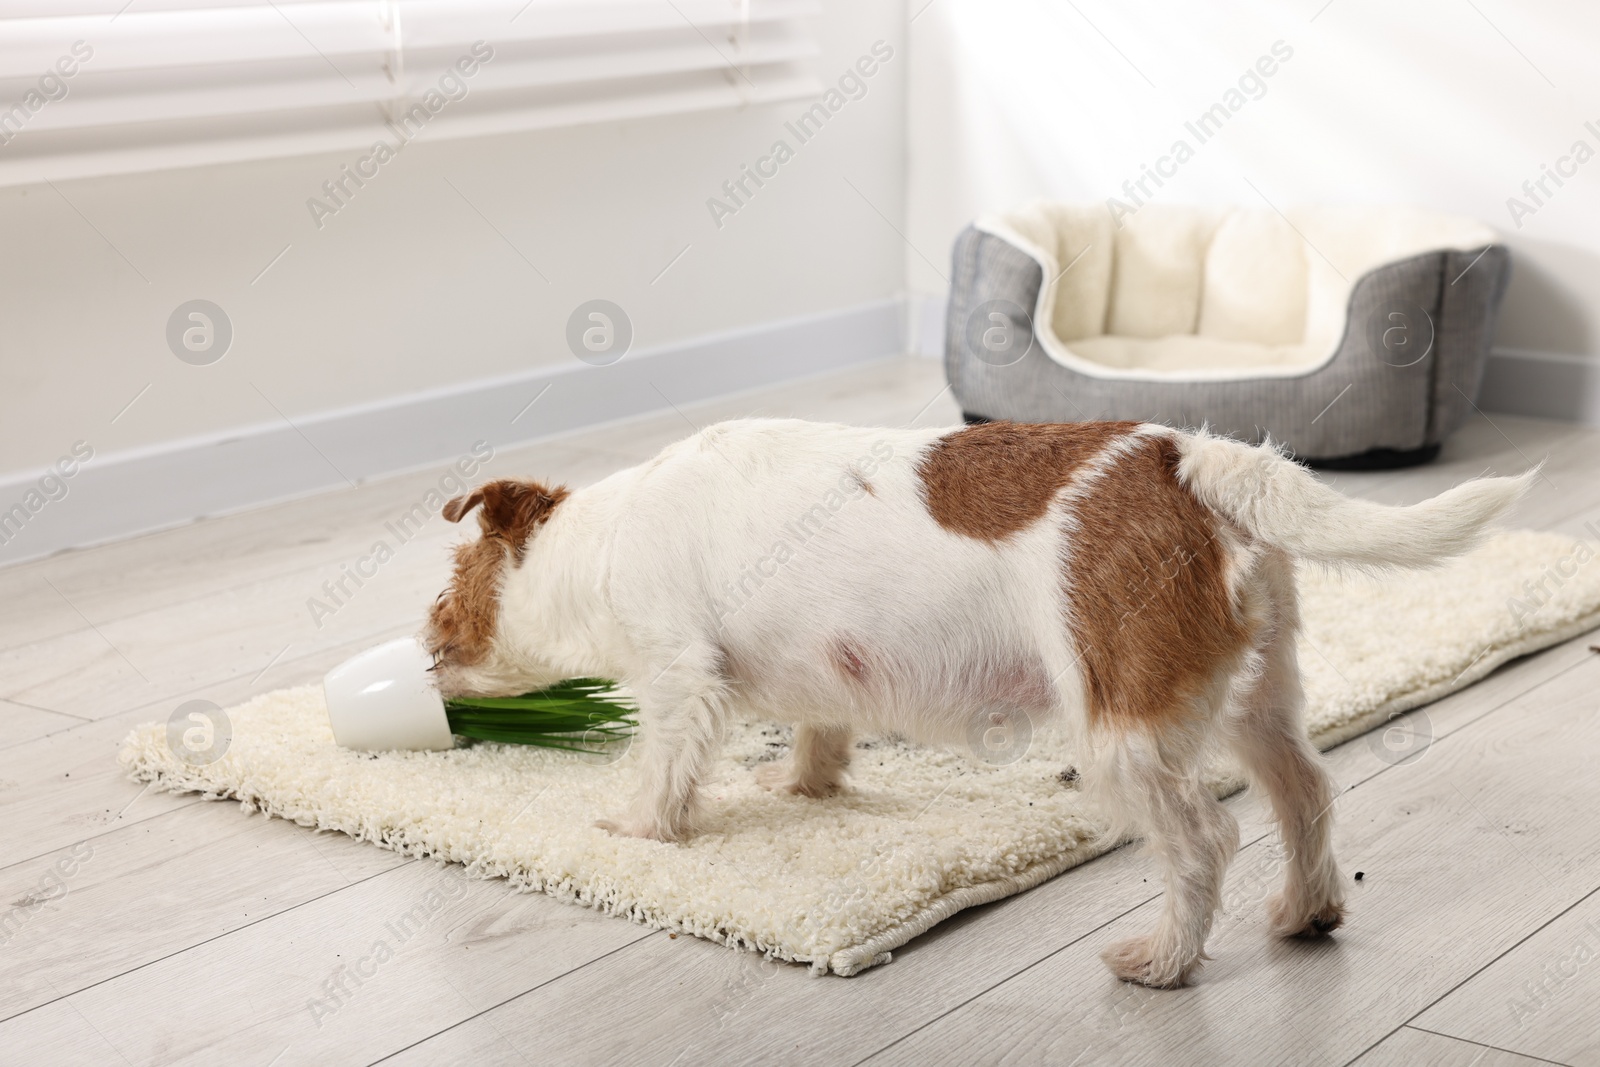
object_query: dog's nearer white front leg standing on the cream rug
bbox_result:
[595,664,725,841]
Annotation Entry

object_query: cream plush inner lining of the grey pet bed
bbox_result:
[978,202,1498,378]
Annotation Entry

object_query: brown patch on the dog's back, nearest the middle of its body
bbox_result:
[917,422,1138,541]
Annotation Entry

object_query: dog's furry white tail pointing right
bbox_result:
[1178,432,1539,568]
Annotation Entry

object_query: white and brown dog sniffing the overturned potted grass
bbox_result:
[421,419,1533,987]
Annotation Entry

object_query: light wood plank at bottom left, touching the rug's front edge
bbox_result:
[0,849,648,1067]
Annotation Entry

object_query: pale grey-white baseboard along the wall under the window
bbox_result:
[0,298,906,565]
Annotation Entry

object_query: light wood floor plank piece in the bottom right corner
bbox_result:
[1416,889,1600,1064]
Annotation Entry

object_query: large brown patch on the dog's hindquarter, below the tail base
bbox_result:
[1066,435,1251,728]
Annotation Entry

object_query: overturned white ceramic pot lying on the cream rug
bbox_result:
[322,637,456,752]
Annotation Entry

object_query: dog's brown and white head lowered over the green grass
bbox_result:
[422,478,568,696]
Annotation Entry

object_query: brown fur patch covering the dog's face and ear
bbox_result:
[424,478,570,667]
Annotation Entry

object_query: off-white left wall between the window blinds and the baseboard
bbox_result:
[0,0,907,476]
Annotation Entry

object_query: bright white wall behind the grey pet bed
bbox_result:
[906,0,1600,360]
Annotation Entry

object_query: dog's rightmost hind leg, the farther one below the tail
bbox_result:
[1227,552,1344,937]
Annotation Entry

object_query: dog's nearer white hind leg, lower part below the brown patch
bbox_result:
[1086,728,1238,989]
